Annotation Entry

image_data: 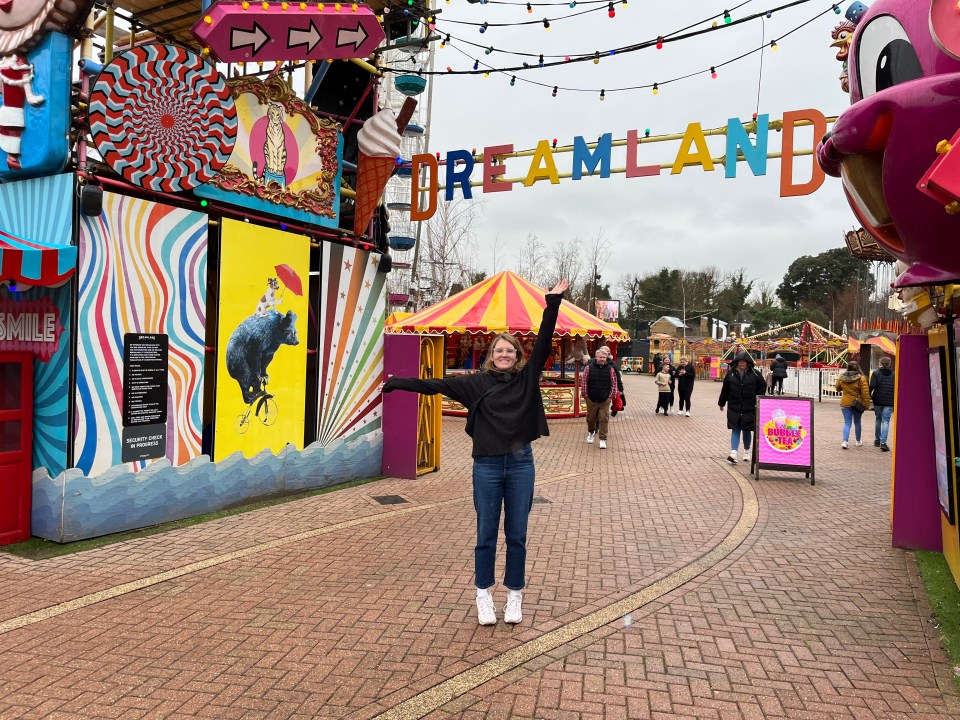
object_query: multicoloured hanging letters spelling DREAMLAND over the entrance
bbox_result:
[410,109,827,220]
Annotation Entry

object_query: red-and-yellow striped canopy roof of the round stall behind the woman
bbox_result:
[386,270,630,342]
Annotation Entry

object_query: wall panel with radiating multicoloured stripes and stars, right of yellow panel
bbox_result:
[317,243,386,447]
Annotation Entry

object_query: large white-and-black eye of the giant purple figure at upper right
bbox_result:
[857,15,923,98]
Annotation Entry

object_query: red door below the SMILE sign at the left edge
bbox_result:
[0,353,33,545]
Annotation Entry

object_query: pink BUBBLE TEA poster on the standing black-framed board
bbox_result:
[757,397,813,470]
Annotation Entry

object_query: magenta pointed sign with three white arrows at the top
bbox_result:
[193,0,385,62]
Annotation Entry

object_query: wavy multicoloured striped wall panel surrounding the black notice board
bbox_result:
[74,193,207,476]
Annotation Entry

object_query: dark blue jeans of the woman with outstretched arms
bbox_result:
[473,443,534,590]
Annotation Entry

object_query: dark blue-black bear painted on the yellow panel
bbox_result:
[227,310,300,404]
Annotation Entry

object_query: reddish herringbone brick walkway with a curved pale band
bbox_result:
[0,376,960,720]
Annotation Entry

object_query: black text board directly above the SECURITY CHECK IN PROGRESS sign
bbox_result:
[123,333,169,427]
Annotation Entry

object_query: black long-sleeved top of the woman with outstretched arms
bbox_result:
[383,294,563,457]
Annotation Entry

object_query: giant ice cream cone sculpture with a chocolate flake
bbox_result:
[353,98,417,235]
